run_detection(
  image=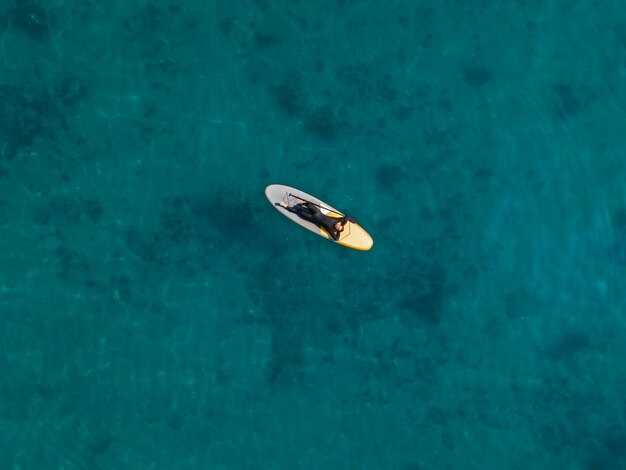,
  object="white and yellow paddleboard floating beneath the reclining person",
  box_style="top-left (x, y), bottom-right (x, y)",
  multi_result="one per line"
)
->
top-left (265, 184), bottom-right (374, 250)
